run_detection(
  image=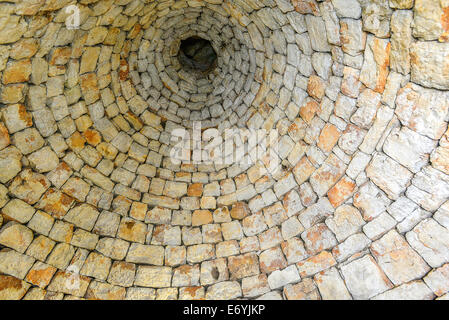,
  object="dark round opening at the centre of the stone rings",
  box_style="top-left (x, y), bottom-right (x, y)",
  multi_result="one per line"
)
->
top-left (178, 37), bottom-right (217, 73)
